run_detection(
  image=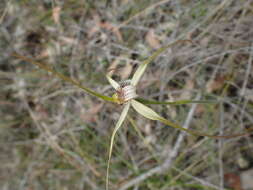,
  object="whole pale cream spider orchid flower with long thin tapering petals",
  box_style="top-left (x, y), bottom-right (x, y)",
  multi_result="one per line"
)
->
top-left (12, 40), bottom-right (253, 190)
